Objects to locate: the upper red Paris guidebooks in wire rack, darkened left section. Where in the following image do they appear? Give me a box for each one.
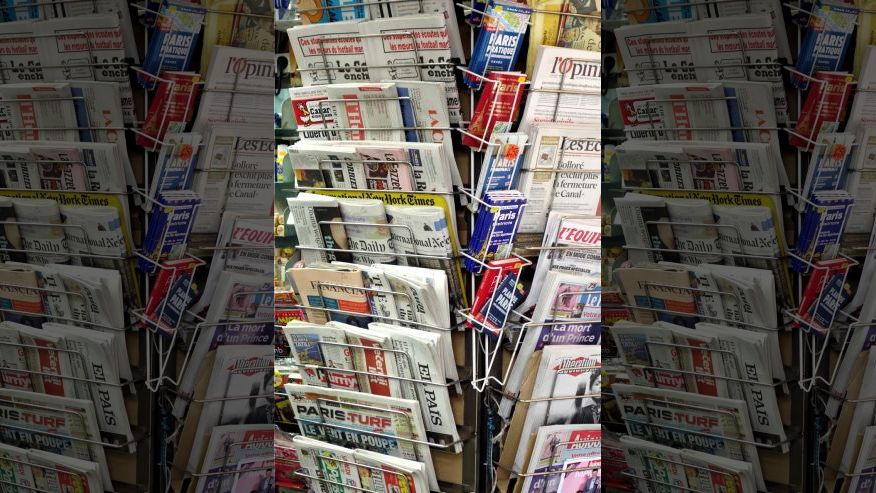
[137,72,201,149]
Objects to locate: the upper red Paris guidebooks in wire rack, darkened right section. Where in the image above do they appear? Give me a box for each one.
[788,72,854,151]
